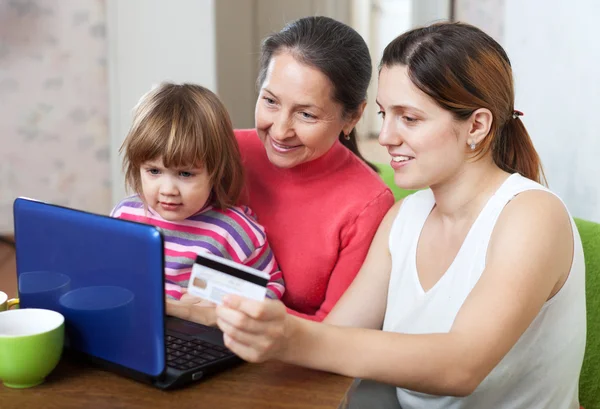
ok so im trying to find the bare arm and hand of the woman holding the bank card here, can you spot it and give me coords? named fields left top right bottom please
left=217, top=191, right=573, bottom=396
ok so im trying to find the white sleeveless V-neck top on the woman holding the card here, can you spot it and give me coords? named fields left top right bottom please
left=383, top=174, right=586, bottom=409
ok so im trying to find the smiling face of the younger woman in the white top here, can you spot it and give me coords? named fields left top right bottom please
left=377, top=65, right=469, bottom=189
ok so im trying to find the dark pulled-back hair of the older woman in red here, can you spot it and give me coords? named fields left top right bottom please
left=256, top=16, right=379, bottom=172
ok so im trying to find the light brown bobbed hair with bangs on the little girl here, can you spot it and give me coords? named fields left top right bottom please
left=119, top=83, right=244, bottom=208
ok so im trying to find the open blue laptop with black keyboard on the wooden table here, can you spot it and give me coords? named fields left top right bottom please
left=13, top=198, right=242, bottom=389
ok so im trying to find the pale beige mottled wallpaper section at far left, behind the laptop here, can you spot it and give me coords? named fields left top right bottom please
left=0, top=0, right=110, bottom=233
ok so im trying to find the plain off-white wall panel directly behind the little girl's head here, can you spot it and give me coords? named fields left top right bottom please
left=106, top=0, right=218, bottom=204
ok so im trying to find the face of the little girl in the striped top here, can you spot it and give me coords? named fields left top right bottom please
left=140, top=158, right=213, bottom=222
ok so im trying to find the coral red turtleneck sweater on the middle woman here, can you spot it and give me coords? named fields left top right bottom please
left=235, top=129, right=394, bottom=321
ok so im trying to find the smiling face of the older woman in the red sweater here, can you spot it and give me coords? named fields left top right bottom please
left=255, top=53, right=355, bottom=168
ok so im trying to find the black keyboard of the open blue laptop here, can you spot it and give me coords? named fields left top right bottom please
left=166, top=335, right=234, bottom=371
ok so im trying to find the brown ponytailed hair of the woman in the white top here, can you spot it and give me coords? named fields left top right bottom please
left=379, top=23, right=546, bottom=183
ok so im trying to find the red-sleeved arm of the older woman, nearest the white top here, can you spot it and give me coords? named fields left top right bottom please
left=288, top=189, right=394, bottom=321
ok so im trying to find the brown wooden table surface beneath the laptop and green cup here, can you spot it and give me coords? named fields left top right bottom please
left=0, top=244, right=352, bottom=409
